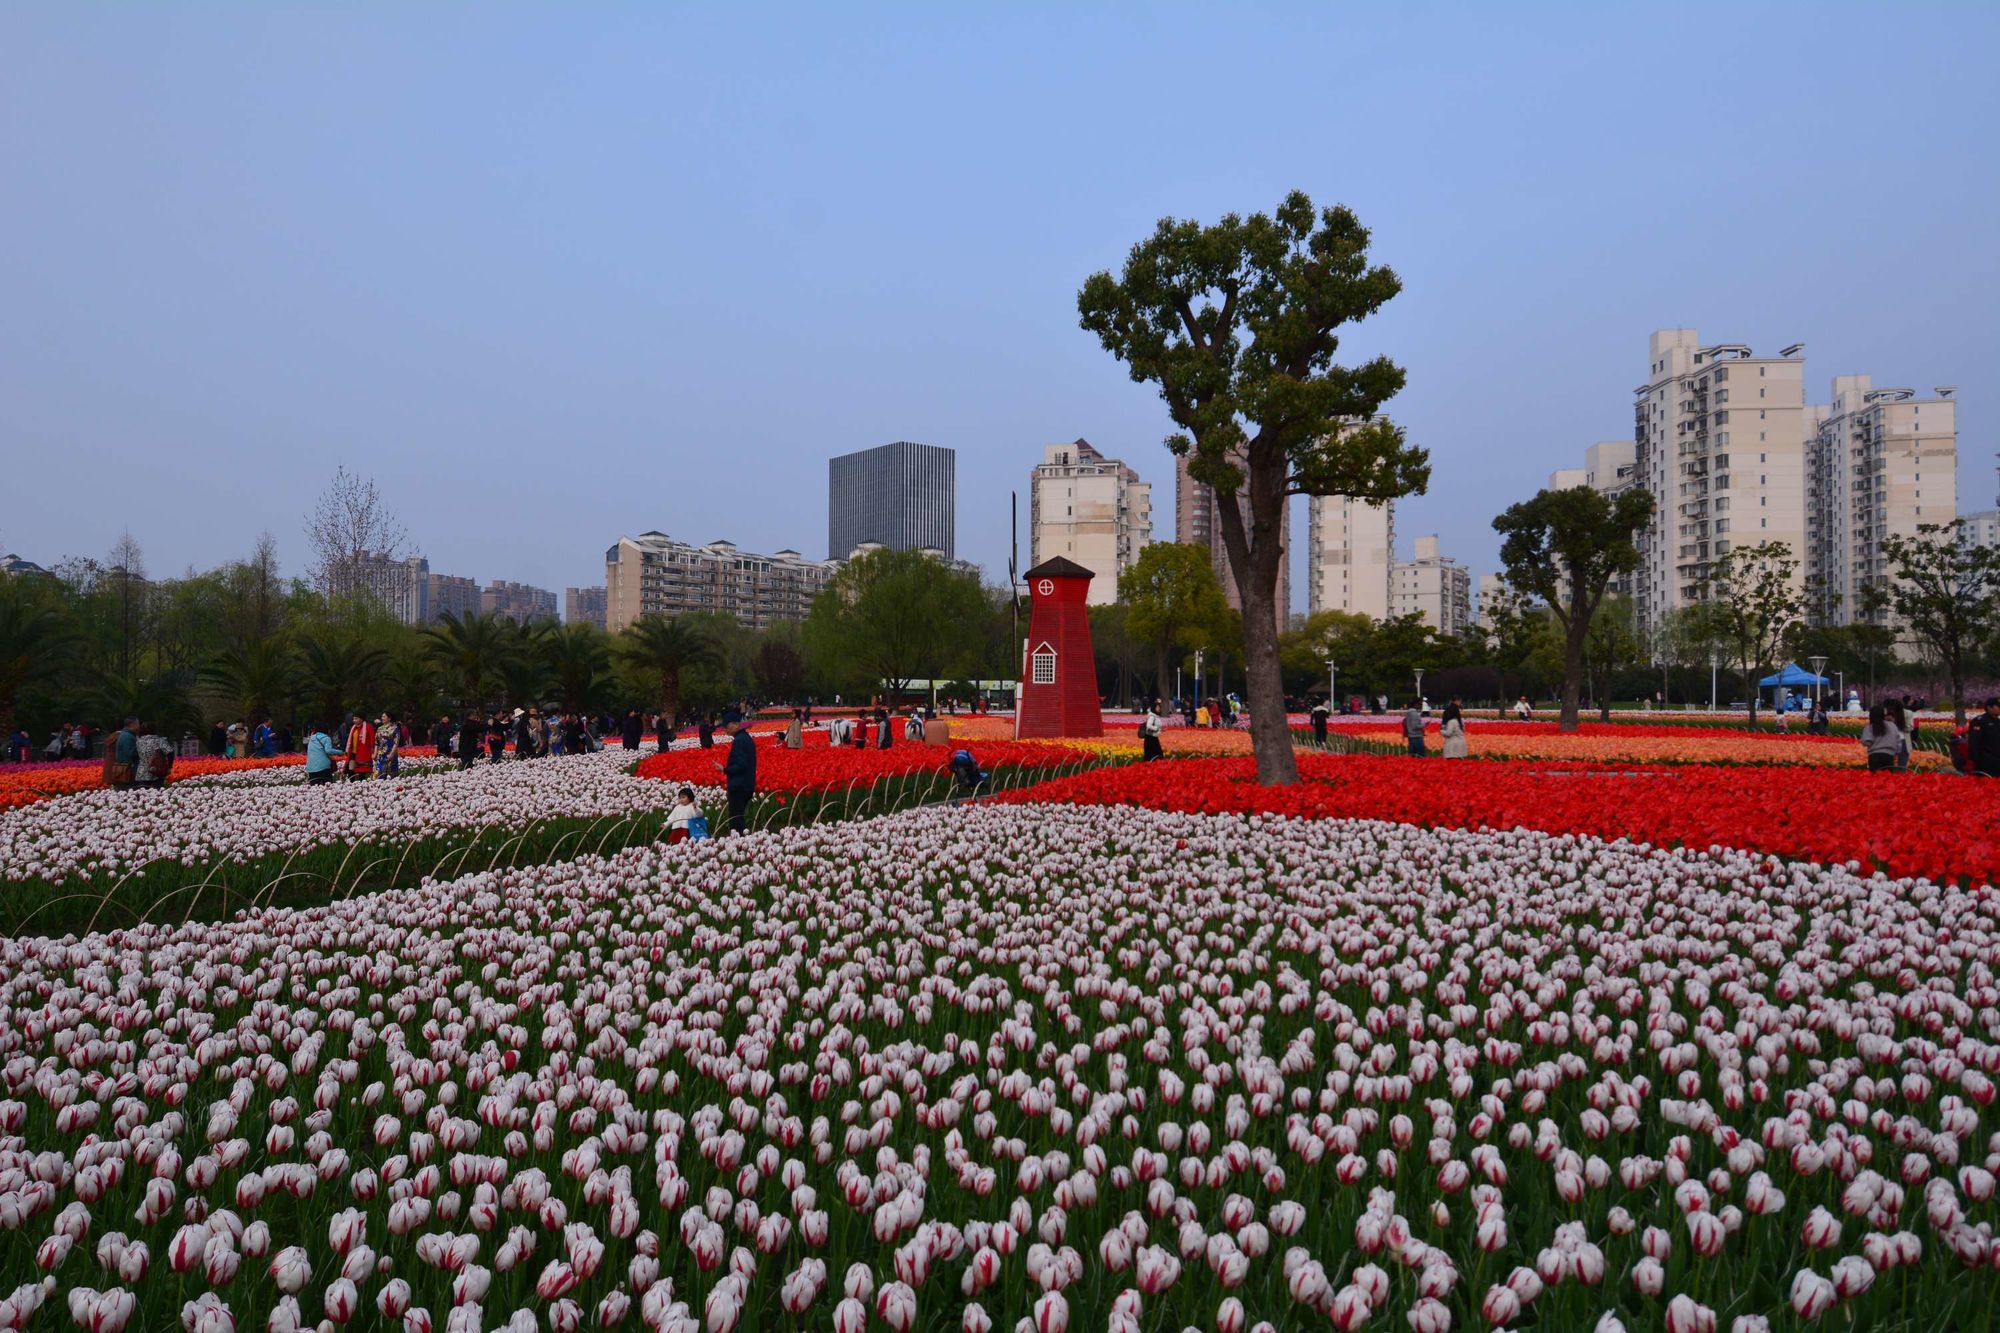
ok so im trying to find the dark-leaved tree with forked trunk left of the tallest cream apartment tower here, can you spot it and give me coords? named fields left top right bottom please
left=1494, top=486, right=1652, bottom=731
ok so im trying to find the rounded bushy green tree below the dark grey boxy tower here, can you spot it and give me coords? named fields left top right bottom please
left=802, top=550, right=988, bottom=695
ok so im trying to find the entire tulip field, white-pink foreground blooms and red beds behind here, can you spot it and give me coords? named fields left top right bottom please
left=0, top=725, right=2000, bottom=1333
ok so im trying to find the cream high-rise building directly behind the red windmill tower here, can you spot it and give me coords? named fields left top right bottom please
left=1028, top=440, right=1152, bottom=606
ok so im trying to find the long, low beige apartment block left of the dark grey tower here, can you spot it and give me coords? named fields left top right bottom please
left=604, top=532, right=840, bottom=634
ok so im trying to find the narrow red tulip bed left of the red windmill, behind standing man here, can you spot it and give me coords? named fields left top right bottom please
left=638, top=731, right=1096, bottom=793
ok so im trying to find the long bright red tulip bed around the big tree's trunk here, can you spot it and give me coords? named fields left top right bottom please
left=1000, top=755, right=2000, bottom=883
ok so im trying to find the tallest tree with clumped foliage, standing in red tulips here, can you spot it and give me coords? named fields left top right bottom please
left=1076, top=190, right=1430, bottom=785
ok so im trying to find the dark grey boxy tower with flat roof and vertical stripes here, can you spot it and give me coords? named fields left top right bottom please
left=826, top=440, right=958, bottom=560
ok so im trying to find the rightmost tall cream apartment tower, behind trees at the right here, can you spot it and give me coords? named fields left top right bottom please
left=1804, top=374, right=1958, bottom=624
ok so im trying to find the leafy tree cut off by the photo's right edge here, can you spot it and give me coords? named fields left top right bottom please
left=1864, top=518, right=2000, bottom=727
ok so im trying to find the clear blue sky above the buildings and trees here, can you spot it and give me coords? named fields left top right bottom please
left=0, top=2, right=2000, bottom=606
